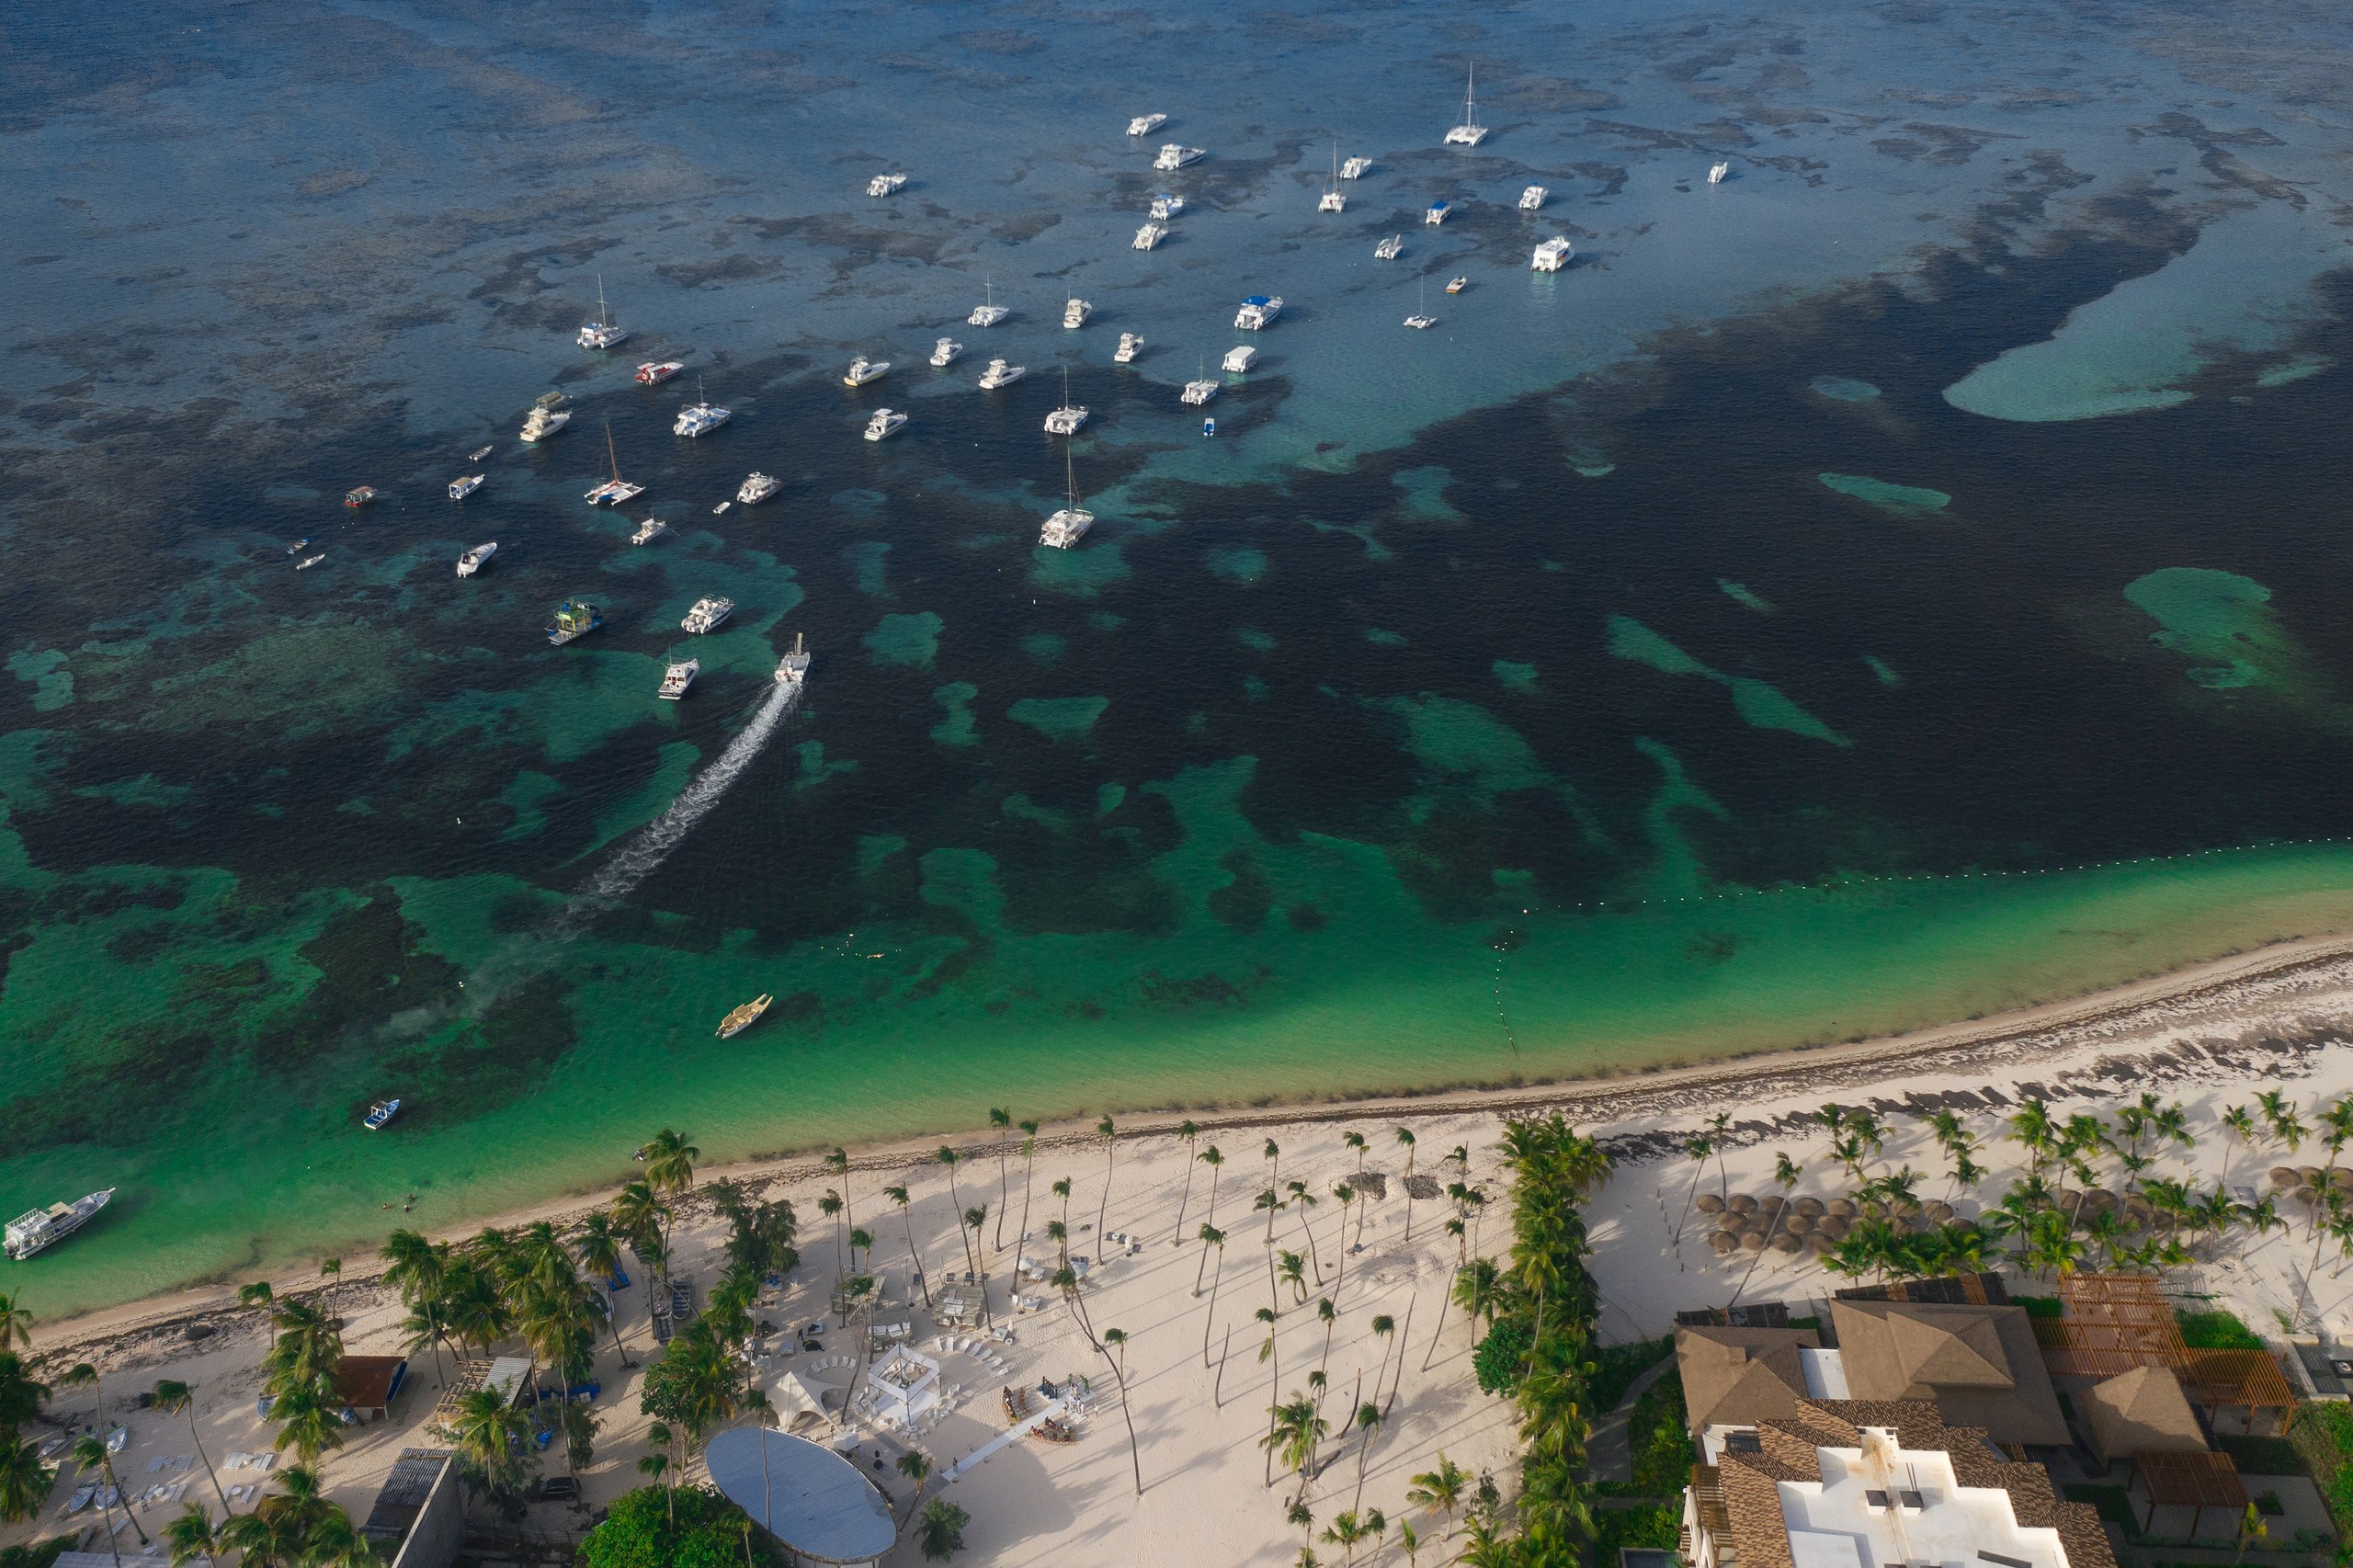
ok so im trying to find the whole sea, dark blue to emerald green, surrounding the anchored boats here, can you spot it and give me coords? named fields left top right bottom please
left=0, top=5, right=2353, bottom=1313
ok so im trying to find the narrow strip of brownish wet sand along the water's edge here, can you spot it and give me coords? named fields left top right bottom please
left=17, top=937, right=2353, bottom=1363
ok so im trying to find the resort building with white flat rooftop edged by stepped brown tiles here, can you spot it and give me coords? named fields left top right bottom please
left=1682, top=1399, right=2115, bottom=1568
